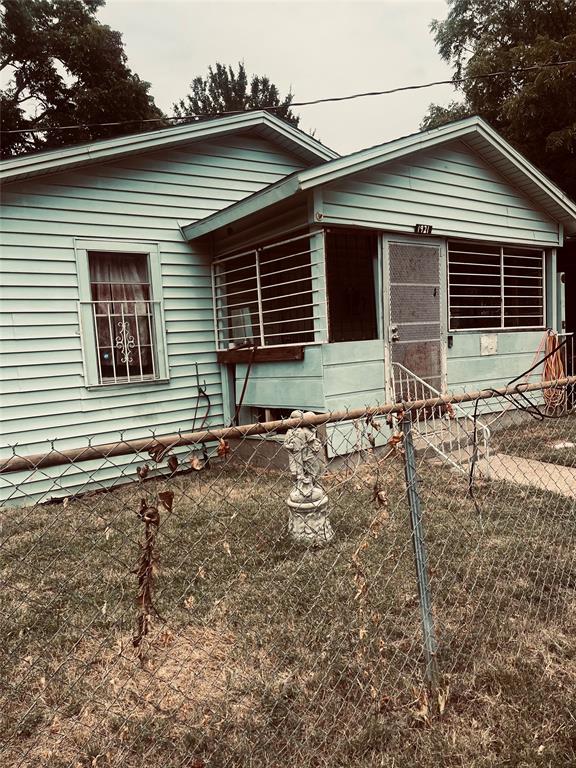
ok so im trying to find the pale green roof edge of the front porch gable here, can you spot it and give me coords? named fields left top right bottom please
left=182, top=117, right=576, bottom=240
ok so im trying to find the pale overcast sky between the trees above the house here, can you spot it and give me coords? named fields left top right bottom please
left=98, top=0, right=455, bottom=153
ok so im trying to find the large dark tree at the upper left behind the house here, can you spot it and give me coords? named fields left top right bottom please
left=0, top=0, right=162, bottom=157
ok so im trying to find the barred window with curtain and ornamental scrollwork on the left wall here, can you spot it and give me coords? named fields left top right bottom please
left=88, top=251, right=157, bottom=384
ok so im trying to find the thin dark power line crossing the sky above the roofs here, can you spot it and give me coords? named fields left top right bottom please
left=0, top=59, right=576, bottom=134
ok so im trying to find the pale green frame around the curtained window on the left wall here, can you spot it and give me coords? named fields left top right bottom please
left=74, top=238, right=170, bottom=389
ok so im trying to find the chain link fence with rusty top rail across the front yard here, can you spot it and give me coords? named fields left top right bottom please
left=0, top=379, right=576, bottom=768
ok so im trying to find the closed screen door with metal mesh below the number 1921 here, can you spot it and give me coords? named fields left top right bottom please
left=388, top=241, right=442, bottom=397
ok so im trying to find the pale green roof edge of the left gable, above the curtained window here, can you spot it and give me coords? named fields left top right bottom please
left=0, top=110, right=338, bottom=181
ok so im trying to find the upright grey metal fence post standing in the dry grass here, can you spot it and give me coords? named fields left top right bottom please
left=401, top=412, right=438, bottom=691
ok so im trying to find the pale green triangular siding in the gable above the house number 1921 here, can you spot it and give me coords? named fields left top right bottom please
left=323, top=142, right=559, bottom=245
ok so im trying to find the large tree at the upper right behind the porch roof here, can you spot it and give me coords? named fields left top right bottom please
left=422, top=0, right=576, bottom=197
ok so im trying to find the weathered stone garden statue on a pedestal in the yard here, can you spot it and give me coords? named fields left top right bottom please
left=284, top=411, right=334, bottom=547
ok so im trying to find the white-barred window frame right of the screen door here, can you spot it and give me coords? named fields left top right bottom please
left=446, top=238, right=548, bottom=334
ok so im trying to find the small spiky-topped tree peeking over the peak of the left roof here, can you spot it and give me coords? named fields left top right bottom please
left=174, top=62, right=300, bottom=126
